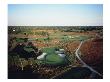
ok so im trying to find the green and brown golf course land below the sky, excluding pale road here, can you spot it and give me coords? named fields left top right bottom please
left=8, top=26, right=103, bottom=79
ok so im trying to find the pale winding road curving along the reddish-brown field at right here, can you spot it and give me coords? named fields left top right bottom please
left=75, top=41, right=102, bottom=77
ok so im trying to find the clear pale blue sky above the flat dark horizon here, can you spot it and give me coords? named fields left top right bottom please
left=8, top=4, right=103, bottom=26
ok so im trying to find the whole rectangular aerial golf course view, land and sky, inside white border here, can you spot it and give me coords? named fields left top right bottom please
left=7, top=4, right=103, bottom=79
